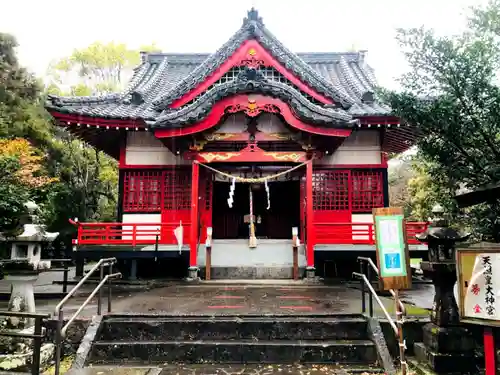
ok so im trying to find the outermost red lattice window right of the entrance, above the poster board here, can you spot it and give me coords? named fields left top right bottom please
left=351, top=171, right=384, bottom=212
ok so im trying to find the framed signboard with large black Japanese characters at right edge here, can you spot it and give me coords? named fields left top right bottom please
left=457, top=243, right=500, bottom=327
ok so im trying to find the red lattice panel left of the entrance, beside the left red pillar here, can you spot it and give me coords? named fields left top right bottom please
left=163, top=168, right=192, bottom=211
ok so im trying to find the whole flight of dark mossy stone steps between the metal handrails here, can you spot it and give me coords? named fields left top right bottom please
left=85, top=315, right=380, bottom=373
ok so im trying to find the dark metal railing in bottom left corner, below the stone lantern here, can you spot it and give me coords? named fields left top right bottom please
left=0, top=311, right=50, bottom=375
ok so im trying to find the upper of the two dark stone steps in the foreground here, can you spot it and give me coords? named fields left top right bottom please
left=96, top=316, right=367, bottom=342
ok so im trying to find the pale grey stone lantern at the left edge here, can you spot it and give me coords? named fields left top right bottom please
left=0, top=202, right=59, bottom=329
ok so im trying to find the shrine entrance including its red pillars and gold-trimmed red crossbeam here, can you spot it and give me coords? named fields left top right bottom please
left=189, top=143, right=314, bottom=279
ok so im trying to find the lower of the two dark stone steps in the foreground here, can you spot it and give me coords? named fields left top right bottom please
left=88, top=340, right=377, bottom=365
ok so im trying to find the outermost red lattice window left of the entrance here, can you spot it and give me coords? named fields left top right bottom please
left=123, top=171, right=162, bottom=212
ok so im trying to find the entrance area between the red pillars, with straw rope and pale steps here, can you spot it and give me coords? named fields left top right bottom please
left=193, top=162, right=309, bottom=279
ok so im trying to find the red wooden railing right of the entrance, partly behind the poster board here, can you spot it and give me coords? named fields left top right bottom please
left=314, top=222, right=428, bottom=245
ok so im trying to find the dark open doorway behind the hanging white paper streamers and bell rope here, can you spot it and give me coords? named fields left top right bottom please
left=212, top=180, right=301, bottom=240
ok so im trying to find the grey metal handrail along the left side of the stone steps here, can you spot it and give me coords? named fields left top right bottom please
left=54, top=258, right=122, bottom=375
